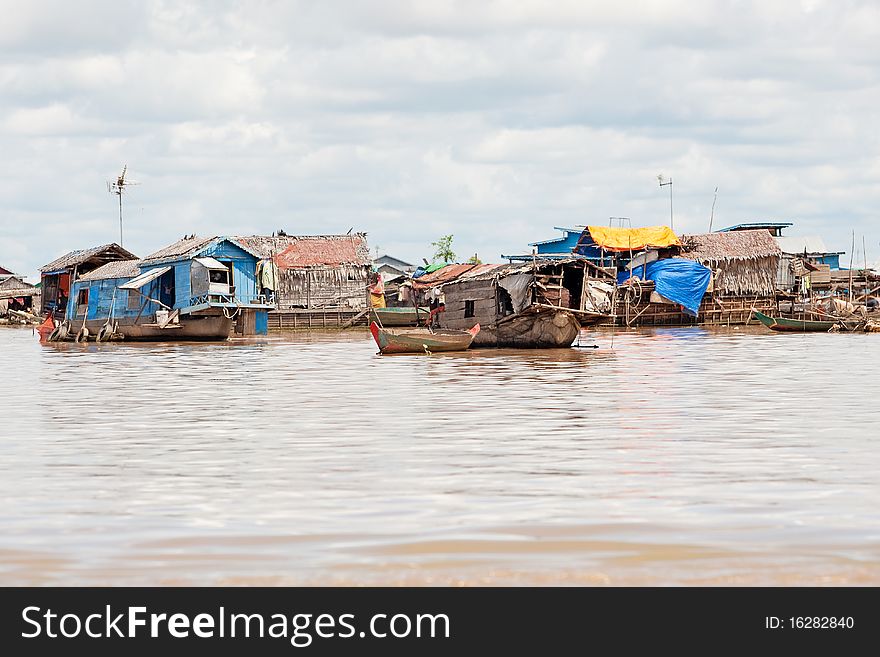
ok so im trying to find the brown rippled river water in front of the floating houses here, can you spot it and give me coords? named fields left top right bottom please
left=0, top=327, right=880, bottom=586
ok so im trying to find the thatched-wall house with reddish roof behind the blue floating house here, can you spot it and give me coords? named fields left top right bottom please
left=236, top=233, right=373, bottom=312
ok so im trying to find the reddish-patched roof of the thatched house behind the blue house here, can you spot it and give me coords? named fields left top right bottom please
left=236, top=233, right=373, bottom=269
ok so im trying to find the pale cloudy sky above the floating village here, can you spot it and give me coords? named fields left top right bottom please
left=0, top=0, right=880, bottom=276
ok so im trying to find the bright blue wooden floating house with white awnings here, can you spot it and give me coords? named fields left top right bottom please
left=49, top=236, right=274, bottom=340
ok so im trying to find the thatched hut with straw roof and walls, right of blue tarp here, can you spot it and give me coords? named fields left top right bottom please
left=681, top=230, right=782, bottom=297
